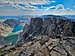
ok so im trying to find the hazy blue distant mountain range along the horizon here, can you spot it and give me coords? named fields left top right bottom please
left=0, top=15, right=75, bottom=20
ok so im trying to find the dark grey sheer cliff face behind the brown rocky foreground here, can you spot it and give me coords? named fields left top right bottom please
left=19, top=16, right=75, bottom=42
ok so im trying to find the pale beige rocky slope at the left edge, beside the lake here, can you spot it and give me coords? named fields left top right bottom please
left=0, top=23, right=12, bottom=37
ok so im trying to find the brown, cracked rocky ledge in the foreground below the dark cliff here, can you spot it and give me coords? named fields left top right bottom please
left=0, top=35, right=75, bottom=56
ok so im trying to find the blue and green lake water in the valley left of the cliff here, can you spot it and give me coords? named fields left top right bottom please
left=5, top=24, right=23, bottom=44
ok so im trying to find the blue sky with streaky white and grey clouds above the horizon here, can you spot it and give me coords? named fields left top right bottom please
left=0, top=0, right=75, bottom=16
